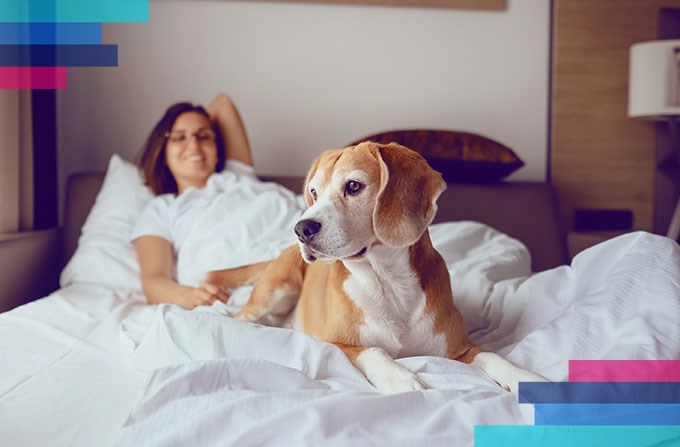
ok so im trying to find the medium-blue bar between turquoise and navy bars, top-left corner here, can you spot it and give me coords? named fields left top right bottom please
left=0, top=22, right=102, bottom=45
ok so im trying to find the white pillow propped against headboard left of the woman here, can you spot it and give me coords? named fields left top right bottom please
left=60, top=154, right=153, bottom=290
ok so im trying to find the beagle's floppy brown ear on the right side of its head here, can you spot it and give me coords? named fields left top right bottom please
left=373, top=143, right=446, bottom=247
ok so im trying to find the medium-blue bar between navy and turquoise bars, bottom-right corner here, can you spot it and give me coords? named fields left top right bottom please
left=534, top=404, right=680, bottom=425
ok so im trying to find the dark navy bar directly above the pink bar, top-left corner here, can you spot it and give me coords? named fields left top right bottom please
left=0, top=45, right=118, bottom=67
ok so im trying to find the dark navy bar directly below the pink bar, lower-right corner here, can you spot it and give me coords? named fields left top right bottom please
left=519, top=382, right=680, bottom=404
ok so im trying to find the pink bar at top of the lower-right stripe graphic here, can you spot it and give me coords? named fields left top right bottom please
left=569, top=360, right=680, bottom=382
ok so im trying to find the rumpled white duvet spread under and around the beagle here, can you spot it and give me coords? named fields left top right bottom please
left=115, top=231, right=680, bottom=446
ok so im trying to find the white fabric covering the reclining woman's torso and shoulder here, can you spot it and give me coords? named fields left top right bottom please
left=130, top=162, right=305, bottom=286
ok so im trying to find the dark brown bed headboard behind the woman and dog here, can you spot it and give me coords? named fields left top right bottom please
left=63, top=172, right=568, bottom=272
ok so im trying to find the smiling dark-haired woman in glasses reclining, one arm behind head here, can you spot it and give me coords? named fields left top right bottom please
left=132, top=94, right=254, bottom=309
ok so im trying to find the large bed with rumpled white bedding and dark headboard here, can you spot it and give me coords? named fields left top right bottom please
left=0, top=145, right=680, bottom=446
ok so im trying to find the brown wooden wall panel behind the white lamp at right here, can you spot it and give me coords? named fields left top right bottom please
left=550, top=0, right=680, bottom=231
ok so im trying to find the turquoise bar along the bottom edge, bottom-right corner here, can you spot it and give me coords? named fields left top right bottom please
left=474, top=425, right=680, bottom=447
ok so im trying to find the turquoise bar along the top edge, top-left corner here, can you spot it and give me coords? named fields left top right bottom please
left=0, top=0, right=149, bottom=23
